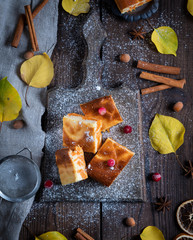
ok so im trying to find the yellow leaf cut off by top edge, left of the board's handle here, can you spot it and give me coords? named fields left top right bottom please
left=62, top=0, right=90, bottom=16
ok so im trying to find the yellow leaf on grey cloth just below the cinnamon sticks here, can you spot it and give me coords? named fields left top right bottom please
left=20, top=53, right=54, bottom=88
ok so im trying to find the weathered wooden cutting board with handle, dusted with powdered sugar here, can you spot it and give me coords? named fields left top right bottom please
left=38, top=15, right=145, bottom=201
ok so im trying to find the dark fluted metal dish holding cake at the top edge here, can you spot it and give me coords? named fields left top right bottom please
left=105, top=0, right=159, bottom=22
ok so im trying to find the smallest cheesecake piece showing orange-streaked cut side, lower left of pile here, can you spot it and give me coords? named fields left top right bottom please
left=55, top=146, right=88, bottom=185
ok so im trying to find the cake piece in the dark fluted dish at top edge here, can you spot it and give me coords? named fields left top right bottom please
left=115, top=0, right=151, bottom=13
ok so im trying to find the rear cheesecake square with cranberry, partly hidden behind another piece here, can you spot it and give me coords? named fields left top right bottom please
left=80, top=96, right=123, bottom=132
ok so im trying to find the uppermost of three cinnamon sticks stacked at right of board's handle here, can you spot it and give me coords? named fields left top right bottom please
left=137, top=60, right=181, bottom=75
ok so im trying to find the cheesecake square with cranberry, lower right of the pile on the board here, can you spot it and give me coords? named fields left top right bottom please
left=87, top=138, right=135, bottom=187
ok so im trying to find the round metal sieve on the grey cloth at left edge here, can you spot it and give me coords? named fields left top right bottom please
left=0, top=148, right=41, bottom=202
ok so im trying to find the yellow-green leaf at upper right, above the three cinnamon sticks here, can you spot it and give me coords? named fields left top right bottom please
left=151, top=27, right=178, bottom=56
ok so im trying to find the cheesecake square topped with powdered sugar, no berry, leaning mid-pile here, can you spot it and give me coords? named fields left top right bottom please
left=63, top=113, right=102, bottom=153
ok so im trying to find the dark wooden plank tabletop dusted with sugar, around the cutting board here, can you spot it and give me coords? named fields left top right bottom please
left=20, top=0, right=193, bottom=240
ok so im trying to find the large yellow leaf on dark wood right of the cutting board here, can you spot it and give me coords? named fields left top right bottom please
left=149, top=114, right=185, bottom=154
